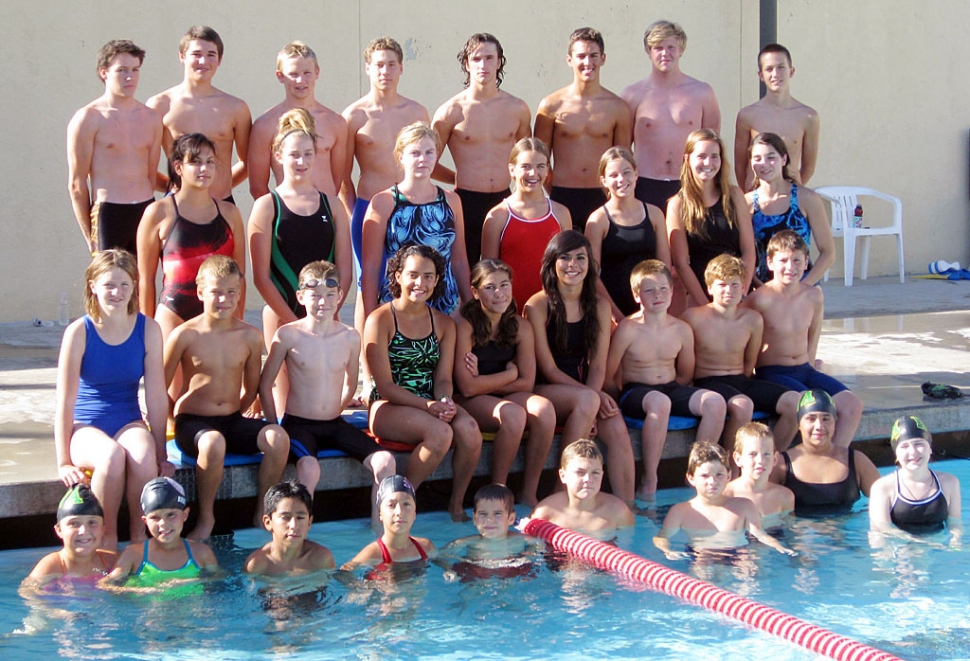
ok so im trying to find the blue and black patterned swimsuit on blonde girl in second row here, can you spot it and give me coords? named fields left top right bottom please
left=378, top=185, right=459, bottom=314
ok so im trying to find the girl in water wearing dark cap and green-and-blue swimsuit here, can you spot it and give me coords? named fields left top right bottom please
left=105, top=477, right=219, bottom=587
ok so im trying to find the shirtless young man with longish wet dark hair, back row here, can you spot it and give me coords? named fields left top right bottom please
left=431, top=32, right=532, bottom=264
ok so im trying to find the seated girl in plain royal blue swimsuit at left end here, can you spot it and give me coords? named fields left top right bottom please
left=54, top=250, right=167, bottom=550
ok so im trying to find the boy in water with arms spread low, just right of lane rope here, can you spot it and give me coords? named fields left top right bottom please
left=653, top=441, right=795, bottom=560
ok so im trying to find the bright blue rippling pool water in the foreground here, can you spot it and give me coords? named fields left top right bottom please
left=0, top=460, right=970, bottom=661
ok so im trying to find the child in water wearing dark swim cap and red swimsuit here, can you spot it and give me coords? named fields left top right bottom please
left=341, top=475, right=434, bottom=570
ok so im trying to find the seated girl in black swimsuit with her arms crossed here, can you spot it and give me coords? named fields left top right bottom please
left=455, top=260, right=556, bottom=505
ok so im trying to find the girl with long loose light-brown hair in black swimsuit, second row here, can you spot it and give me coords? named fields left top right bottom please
left=667, top=129, right=755, bottom=313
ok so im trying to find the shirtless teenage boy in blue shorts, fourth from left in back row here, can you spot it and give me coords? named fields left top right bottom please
left=340, top=37, right=431, bottom=276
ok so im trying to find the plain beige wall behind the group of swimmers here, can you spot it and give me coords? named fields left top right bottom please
left=0, top=0, right=970, bottom=321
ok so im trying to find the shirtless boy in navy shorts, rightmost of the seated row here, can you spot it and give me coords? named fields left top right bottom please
left=744, top=230, right=863, bottom=449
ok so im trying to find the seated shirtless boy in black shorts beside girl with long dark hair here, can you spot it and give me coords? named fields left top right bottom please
left=606, top=259, right=726, bottom=501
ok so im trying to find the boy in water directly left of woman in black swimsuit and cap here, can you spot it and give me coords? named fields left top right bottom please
left=724, top=422, right=795, bottom=529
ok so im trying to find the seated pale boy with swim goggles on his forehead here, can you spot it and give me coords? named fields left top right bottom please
left=259, top=261, right=396, bottom=528
